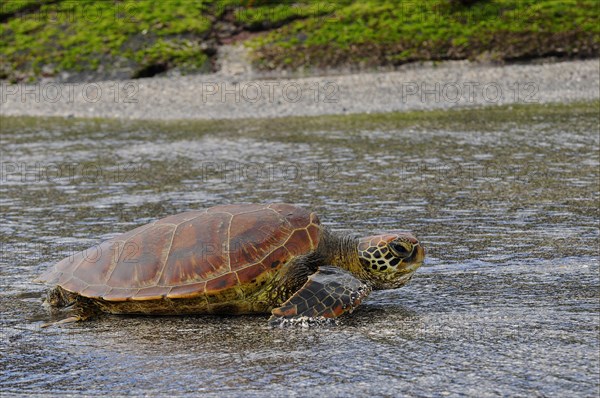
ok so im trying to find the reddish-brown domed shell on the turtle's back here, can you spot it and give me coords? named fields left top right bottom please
left=39, top=204, right=320, bottom=301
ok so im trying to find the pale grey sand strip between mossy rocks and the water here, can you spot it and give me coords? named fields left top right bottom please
left=0, top=59, right=600, bottom=120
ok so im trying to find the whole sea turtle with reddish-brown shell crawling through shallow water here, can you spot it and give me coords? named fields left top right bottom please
left=38, top=203, right=425, bottom=324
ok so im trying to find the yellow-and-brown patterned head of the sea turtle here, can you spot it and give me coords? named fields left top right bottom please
left=358, top=233, right=425, bottom=290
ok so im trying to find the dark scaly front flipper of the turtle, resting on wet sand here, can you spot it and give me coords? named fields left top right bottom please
left=269, top=266, right=371, bottom=326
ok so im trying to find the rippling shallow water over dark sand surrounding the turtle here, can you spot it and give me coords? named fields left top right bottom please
left=0, top=103, right=600, bottom=396
